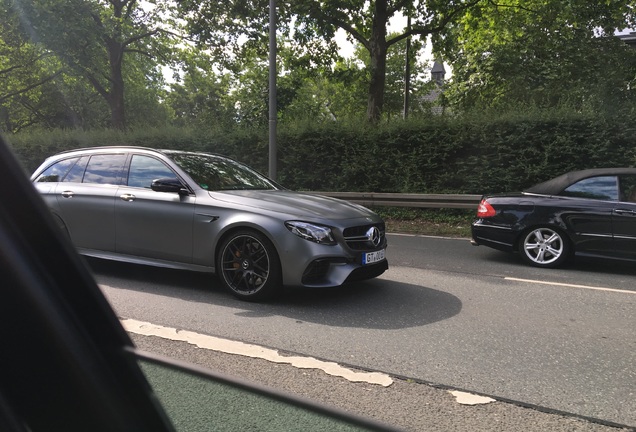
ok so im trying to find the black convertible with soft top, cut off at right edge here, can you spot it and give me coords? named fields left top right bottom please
left=472, top=168, right=636, bottom=267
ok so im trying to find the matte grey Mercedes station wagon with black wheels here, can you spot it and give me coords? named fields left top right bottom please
left=31, top=147, right=388, bottom=300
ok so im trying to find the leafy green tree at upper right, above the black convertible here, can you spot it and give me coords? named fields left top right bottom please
left=436, top=0, right=636, bottom=111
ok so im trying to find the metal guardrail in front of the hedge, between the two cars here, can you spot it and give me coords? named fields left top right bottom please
left=312, top=192, right=481, bottom=209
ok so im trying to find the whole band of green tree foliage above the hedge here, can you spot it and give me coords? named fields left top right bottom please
left=0, top=0, right=636, bottom=132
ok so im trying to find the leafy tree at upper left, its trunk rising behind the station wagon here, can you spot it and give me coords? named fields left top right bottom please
left=9, top=0, right=179, bottom=129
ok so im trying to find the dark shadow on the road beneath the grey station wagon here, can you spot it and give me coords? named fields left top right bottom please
left=87, top=259, right=462, bottom=329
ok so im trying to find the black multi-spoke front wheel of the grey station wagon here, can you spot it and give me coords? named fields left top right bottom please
left=217, top=231, right=281, bottom=301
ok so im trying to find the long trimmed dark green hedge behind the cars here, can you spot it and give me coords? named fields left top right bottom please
left=9, top=114, right=636, bottom=194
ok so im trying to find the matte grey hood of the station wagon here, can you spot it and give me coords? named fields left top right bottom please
left=208, top=190, right=379, bottom=221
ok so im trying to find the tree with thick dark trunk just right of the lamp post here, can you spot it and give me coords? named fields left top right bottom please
left=180, top=0, right=485, bottom=122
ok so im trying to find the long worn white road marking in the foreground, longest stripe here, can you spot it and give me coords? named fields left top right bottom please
left=121, top=319, right=393, bottom=387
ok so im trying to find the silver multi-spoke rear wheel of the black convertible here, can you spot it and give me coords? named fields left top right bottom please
left=519, top=227, right=570, bottom=267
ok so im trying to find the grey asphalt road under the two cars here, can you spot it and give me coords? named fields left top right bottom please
left=90, top=235, right=636, bottom=430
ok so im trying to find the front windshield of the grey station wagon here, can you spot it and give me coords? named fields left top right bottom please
left=169, top=153, right=277, bottom=191
